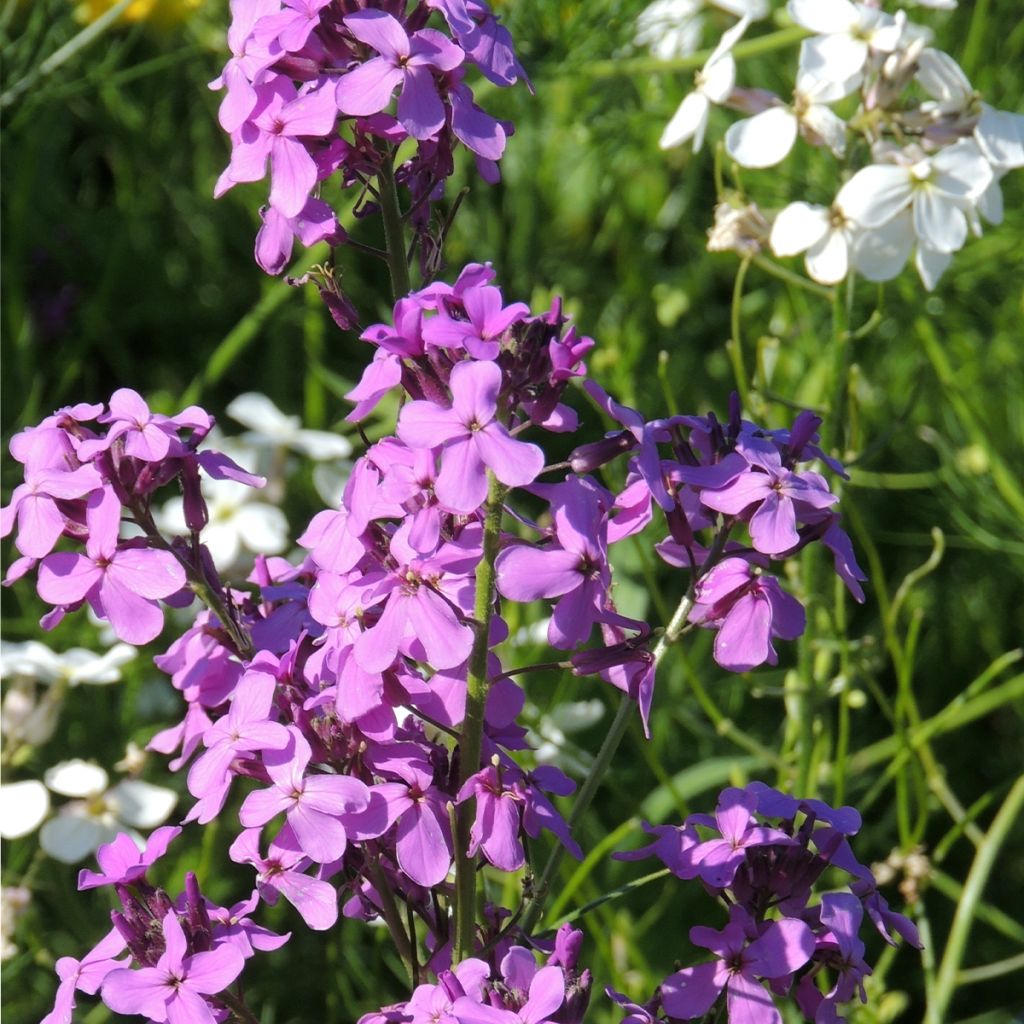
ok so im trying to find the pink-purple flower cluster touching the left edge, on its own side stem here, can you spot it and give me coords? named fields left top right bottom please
left=0, top=388, right=263, bottom=644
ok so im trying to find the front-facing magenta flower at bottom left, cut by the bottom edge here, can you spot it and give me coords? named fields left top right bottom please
left=101, top=910, right=245, bottom=1024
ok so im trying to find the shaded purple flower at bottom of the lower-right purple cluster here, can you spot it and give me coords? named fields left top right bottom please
left=662, top=906, right=814, bottom=1024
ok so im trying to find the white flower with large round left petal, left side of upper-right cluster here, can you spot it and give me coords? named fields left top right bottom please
left=725, top=57, right=856, bottom=168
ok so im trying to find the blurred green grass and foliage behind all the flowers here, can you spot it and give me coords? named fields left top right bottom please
left=0, top=0, right=1024, bottom=1024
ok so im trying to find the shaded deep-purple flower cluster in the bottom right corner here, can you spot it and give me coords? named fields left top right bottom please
left=609, top=782, right=921, bottom=1024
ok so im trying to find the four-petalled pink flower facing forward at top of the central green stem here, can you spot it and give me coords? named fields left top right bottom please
left=398, top=361, right=544, bottom=515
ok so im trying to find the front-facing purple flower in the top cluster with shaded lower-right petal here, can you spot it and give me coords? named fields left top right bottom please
left=336, top=10, right=465, bottom=139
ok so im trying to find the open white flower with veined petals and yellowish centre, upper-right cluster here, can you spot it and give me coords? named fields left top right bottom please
left=836, top=139, right=992, bottom=253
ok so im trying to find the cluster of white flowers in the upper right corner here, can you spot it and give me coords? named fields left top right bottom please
left=660, top=0, right=1024, bottom=289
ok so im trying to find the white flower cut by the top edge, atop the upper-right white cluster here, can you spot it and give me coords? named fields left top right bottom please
left=786, top=0, right=903, bottom=81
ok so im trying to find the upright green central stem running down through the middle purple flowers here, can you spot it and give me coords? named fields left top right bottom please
left=453, top=470, right=506, bottom=964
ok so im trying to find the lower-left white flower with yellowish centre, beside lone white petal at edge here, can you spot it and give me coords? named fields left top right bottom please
left=39, top=759, right=178, bottom=864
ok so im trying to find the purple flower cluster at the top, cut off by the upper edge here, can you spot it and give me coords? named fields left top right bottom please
left=207, top=0, right=526, bottom=273
